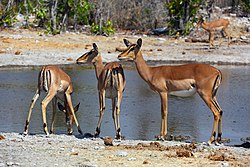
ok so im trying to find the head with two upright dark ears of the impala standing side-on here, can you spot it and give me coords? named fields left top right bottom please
left=118, top=38, right=142, bottom=61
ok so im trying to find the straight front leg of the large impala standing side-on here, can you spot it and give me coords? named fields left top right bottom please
left=158, top=92, right=168, bottom=140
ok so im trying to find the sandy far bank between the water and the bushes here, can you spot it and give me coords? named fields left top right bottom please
left=0, top=29, right=250, bottom=66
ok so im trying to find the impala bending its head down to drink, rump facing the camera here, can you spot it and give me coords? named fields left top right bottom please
left=24, top=65, right=82, bottom=135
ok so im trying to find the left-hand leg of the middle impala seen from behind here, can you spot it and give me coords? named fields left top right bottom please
left=94, top=90, right=105, bottom=137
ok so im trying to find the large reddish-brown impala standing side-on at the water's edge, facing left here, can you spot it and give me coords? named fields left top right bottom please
left=118, top=39, right=222, bottom=144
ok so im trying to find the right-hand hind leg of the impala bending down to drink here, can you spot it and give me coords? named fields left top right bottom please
left=42, top=92, right=56, bottom=136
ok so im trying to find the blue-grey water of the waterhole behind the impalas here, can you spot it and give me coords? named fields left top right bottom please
left=0, top=66, right=250, bottom=144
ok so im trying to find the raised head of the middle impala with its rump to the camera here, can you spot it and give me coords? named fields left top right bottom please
left=76, top=43, right=100, bottom=64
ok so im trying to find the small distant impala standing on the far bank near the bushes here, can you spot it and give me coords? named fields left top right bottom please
left=197, top=17, right=230, bottom=47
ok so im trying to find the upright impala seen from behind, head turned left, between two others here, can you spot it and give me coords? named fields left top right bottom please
left=76, top=43, right=126, bottom=139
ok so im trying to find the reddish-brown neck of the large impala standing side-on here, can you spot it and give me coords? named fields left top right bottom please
left=134, top=51, right=151, bottom=82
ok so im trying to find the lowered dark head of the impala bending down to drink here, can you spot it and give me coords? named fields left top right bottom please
left=57, top=102, right=80, bottom=135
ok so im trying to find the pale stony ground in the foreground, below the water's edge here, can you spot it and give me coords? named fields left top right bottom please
left=0, top=133, right=250, bottom=167
